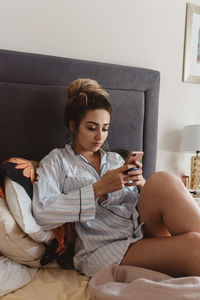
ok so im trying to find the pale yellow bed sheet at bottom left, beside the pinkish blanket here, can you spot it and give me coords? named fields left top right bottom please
left=1, top=268, right=89, bottom=300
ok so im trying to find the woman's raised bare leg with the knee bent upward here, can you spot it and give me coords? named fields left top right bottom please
left=138, top=172, right=200, bottom=236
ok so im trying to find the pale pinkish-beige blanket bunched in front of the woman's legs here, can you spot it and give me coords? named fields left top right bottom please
left=89, top=266, right=200, bottom=300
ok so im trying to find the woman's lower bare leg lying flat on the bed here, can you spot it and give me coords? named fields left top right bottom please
left=121, top=232, right=200, bottom=276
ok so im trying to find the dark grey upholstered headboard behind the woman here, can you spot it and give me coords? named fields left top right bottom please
left=0, top=50, right=160, bottom=178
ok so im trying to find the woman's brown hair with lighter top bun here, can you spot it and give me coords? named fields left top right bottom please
left=64, top=78, right=112, bottom=129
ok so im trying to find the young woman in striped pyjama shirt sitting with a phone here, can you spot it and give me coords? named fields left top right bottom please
left=33, top=79, right=200, bottom=276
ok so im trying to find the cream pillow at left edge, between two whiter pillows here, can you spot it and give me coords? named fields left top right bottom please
left=0, top=197, right=45, bottom=267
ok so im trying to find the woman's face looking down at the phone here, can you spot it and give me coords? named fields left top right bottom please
left=70, top=109, right=110, bottom=154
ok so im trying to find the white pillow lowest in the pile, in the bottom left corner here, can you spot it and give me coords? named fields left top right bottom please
left=0, top=256, right=37, bottom=297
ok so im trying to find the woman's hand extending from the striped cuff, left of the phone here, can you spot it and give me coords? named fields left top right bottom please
left=93, top=164, right=135, bottom=198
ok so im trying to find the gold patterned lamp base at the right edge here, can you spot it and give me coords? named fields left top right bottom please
left=190, top=152, right=200, bottom=190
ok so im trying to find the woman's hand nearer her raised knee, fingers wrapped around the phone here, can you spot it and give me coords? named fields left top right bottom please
left=125, top=160, right=145, bottom=190
